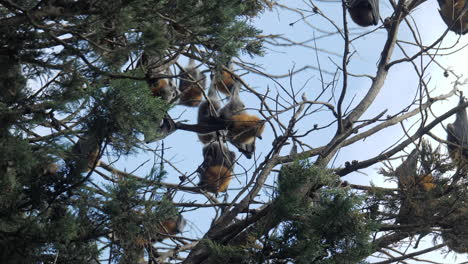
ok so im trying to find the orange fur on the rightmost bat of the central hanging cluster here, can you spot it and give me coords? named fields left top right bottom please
left=228, top=114, right=265, bottom=144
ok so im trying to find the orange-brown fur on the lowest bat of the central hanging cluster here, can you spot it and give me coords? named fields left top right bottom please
left=202, top=165, right=232, bottom=193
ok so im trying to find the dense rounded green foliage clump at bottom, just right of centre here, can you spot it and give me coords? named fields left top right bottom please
left=265, top=161, right=376, bottom=263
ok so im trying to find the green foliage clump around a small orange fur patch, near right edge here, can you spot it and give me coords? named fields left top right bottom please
left=374, top=141, right=461, bottom=227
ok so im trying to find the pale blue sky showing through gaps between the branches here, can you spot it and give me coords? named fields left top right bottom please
left=88, top=0, right=468, bottom=263
